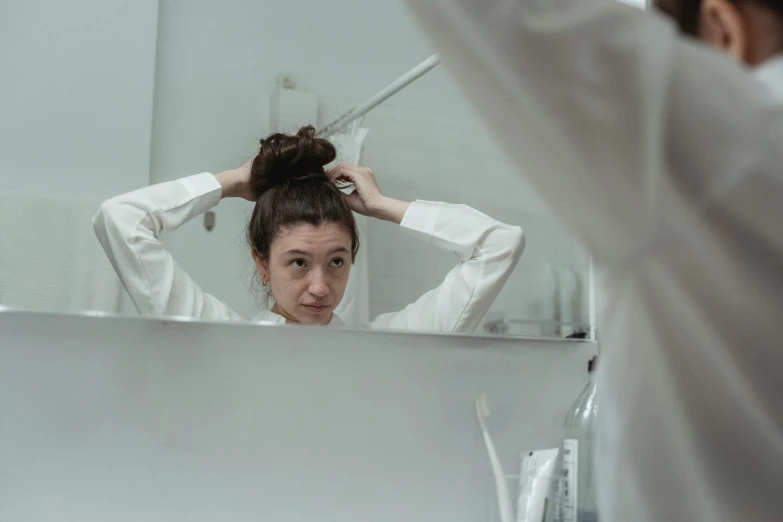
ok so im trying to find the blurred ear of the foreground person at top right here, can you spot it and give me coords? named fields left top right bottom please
left=699, top=0, right=748, bottom=63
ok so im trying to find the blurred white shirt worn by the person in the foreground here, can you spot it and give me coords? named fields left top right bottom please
left=408, top=0, right=783, bottom=522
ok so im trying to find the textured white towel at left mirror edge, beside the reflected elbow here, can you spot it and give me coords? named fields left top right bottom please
left=0, top=194, right=123, bottom=312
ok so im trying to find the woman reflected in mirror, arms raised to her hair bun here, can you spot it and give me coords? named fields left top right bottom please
left=93, top=127, right=524, bottom=332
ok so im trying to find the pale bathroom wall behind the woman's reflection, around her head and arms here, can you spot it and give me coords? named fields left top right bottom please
left=147, top=0, right=585, bottom=324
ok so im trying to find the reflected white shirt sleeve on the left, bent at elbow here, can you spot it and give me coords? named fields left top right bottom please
left=93, top=173, right=241, bottom=320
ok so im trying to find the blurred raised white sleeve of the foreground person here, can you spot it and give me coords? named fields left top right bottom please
left=408, top=0, right=772, bottom=264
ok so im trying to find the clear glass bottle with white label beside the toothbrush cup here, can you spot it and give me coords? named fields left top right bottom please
left=559, top=357, right=598, bottom=522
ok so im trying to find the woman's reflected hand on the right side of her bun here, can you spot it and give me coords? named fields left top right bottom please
left=326, top=163, right=409, bottom=224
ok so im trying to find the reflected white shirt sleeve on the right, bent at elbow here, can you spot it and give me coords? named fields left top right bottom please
left=371, top=201, right=524, bottom=332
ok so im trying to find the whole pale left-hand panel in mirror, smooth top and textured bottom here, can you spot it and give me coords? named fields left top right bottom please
left=0, top=0, right=158, bottom=311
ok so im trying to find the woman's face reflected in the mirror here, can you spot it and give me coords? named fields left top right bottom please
left=256, top=223, right=351, bottom=324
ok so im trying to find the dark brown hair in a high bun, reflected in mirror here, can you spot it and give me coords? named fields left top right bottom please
left=247, top=126, right=359, bottom=261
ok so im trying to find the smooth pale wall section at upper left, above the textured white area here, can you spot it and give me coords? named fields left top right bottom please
left=0, top=0, right=158, bottom=203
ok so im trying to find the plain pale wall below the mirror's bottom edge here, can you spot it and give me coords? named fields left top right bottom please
left=0, top=312, right=594, bottom=522
